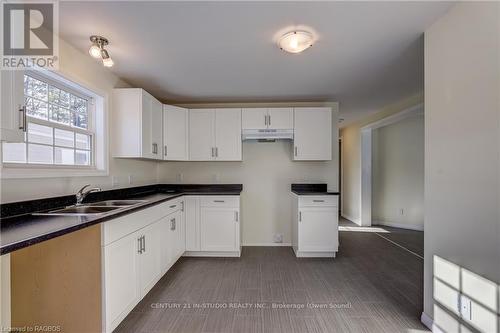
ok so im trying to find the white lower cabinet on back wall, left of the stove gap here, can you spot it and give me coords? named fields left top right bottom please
left=184, top=196, right=241, bottom=257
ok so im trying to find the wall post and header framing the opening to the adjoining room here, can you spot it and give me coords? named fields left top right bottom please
left=340, top=94, right=423, bottom=224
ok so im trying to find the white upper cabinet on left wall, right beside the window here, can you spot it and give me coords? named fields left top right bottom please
left=112, top=88, right=163, bottom=159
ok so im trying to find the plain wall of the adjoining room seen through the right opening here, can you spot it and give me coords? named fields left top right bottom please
left=372, top=115, right=424, bottom=230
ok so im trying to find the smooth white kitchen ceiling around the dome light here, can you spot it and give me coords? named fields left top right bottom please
left=60, top=1, right=452, bottom=124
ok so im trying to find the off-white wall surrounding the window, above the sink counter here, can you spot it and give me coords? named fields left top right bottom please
left=0, top=36, right=157, bottom=203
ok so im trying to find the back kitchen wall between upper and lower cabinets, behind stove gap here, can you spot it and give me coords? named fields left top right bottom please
left=159, top=108, right=338, bottom=245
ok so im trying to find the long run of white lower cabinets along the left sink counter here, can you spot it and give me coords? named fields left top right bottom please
left=102, top=200, right=185, bottom=332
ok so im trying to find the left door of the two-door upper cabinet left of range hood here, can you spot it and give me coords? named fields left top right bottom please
left=189, top=109, right=215, bottom=161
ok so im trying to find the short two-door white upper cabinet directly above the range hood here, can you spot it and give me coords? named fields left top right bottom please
left=242, top=108, right=293, bottom=129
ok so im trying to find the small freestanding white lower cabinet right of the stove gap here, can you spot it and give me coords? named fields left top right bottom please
left=292, top=195, right=339, bottom=257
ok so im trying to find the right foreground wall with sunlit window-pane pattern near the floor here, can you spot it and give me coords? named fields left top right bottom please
left=424, top=2, right=500, bottom=332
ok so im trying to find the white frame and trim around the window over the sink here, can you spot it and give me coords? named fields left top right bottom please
left=0, top=69, right=109, bottom=179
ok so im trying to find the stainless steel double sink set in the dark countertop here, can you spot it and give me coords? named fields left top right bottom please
left=33, top=200, right=147, bottom=216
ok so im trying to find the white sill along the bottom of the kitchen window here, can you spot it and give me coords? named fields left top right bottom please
left=0, top=164, right=109, bottom=179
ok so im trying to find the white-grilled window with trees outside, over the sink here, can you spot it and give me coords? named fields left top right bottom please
left=2, top=73, right=95, bottom=168
